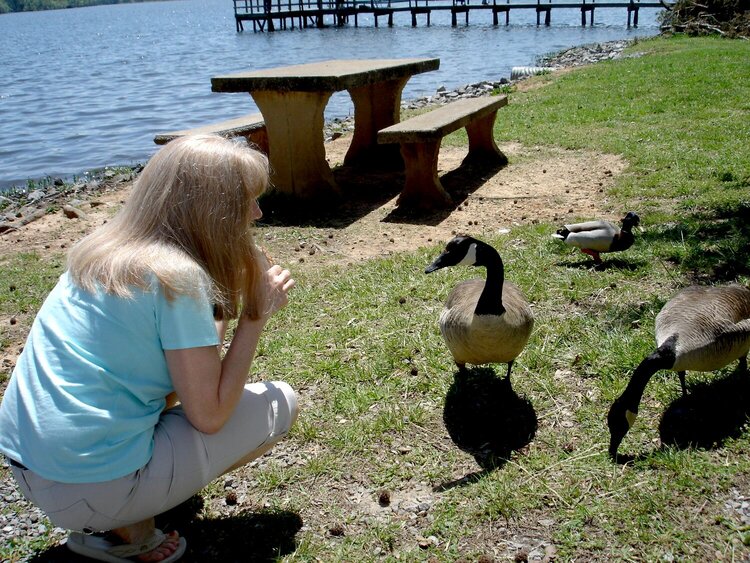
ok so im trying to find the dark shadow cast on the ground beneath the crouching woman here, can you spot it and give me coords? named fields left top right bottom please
left=30, top=495, right=303, bottom=563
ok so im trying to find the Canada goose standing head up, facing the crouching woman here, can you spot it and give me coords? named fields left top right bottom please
left=425, top=236, right=534, bottom=388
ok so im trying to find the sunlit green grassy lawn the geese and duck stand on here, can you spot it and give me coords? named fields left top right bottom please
left=0, top=38, right=750, bottom=561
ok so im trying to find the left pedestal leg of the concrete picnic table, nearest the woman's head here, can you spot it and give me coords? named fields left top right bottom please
left=251, top=90, right=337, bottom=199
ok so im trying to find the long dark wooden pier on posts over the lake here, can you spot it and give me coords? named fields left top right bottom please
left=234, top=0, right=668, bottom=31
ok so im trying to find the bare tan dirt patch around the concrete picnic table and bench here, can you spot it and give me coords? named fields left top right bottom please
left=0, top=138, right=626, bottom=268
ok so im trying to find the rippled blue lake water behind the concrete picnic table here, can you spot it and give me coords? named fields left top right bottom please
left=0, top=0, right=659, bottom=188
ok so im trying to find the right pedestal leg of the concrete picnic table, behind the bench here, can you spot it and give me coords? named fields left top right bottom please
left=344, top=77, right=409, bottom=169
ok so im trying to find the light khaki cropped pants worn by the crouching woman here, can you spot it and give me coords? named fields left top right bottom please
left=11, top=381, right=297, bottom=533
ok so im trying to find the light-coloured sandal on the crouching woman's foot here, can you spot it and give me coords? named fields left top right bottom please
left=67, top=529, right=187, bottom=563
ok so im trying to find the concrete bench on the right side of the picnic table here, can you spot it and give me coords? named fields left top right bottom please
left=378, top=96, right=508, bottom=209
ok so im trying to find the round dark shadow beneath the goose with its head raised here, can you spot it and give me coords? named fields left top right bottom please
left=443, top=367, right=537, bottom=476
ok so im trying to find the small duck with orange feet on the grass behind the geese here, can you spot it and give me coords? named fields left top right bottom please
left=552, top=211, right=641, bottom=264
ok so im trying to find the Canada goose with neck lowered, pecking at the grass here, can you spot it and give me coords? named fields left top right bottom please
left=607, top=284, right=750, bottom=459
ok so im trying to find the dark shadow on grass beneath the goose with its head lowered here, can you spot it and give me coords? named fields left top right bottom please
left=616, top=369, right=750, bottom=465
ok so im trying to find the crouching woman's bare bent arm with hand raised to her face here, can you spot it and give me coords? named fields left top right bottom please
left=165, top=265, right=294, bottom=434
